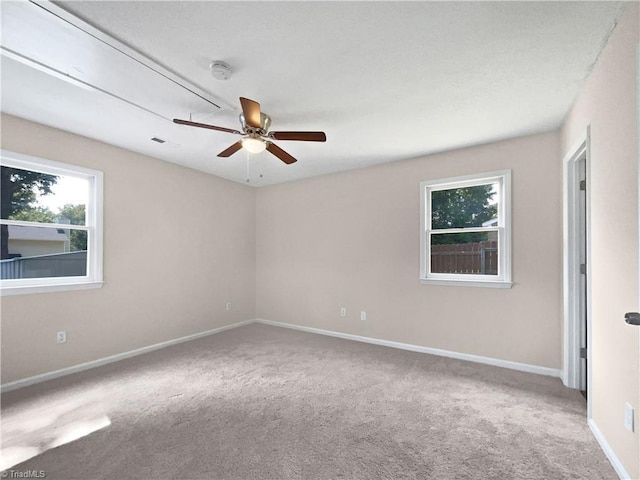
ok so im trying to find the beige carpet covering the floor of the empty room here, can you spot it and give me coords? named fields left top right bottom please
left=2, top=325, right=617, bottom=480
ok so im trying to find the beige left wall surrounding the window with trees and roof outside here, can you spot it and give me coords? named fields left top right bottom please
left=1, top=116, right=255, bottom=383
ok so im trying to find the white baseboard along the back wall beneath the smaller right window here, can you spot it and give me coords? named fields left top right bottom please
left=255, top=318, right=560, bottom=378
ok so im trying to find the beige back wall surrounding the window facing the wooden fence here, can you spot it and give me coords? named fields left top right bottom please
left=256, top=132, right=562, bottom=369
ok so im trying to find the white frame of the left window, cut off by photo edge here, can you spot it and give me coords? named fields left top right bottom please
left=0, top=150, right=103, bottom=296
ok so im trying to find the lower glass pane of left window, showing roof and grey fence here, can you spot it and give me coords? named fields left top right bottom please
left=0, top=225, right=87, bottom=280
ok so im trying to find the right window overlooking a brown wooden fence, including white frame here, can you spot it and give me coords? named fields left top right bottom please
left=420, top=170, right=512, bottom=288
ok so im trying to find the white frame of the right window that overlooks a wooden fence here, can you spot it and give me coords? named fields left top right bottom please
left=420, top=170, right=513, bottom=288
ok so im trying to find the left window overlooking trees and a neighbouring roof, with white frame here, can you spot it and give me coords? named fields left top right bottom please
left=0, top=150, right=102, bottom=295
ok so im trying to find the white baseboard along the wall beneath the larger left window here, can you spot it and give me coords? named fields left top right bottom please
left=0, top=319, right=255, bottom=393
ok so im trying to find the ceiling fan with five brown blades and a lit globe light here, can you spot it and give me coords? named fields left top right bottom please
left=173, top=97, right=327, bottom=164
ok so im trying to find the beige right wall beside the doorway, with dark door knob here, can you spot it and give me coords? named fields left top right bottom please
left=562, top=3, right=640, bottom=478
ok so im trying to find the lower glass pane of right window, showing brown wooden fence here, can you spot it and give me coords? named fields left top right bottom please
left=430, top=231, right=498, bottom=275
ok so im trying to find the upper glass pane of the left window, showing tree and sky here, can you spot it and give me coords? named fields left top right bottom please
left=1, top=166, right=89, bottom=225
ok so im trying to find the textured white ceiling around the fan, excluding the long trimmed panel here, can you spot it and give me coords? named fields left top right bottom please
left=2, top=1, right=624, bottom=186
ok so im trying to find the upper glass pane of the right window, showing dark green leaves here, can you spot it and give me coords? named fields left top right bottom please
left=431, top=183, right=499, bottom=229
